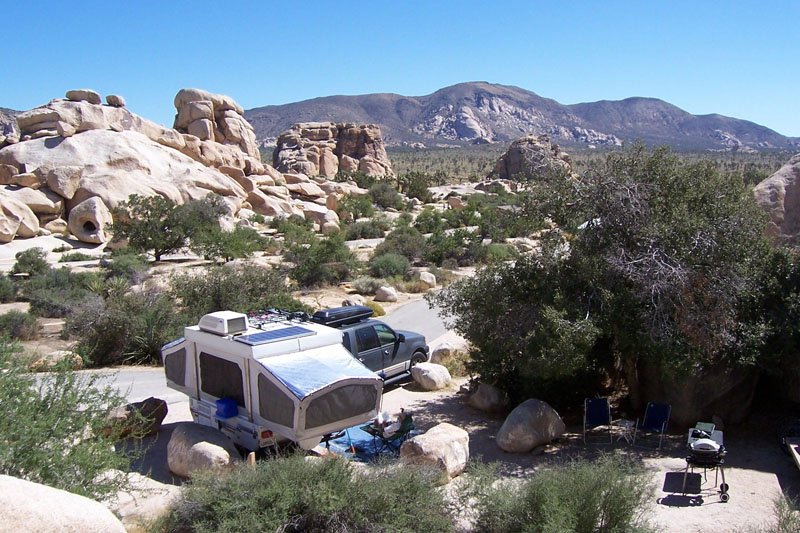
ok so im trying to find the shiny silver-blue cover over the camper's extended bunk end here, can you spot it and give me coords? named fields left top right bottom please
left=258, top=344, right=380, bottom=400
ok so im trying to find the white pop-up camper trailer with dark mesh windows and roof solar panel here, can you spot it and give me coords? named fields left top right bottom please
left=161, top=311, right=383, bottom=450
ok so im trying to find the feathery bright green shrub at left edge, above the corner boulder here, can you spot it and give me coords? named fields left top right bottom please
left=0, top=339, right=136, bottom=499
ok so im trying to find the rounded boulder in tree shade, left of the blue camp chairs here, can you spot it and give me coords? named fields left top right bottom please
left=496, top=399, right=566, bottom=453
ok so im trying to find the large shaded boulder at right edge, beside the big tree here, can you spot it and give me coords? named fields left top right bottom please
left=753, top=154, right=800, bottom=244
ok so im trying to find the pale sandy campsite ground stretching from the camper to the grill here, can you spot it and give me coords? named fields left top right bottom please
left=131, top=366, right=800, bottom=533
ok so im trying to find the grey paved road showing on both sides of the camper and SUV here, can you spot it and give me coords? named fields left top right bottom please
left=101, top=300, right=447, bottom=404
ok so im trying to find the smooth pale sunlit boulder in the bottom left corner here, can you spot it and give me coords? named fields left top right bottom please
left=0, top=475, right=125, bottom=533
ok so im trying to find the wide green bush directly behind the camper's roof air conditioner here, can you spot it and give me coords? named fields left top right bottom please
left=170, top=265, right=310, bottom=324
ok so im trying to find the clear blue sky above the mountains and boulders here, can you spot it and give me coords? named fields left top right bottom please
left=6, top=0, right=800, bottom=136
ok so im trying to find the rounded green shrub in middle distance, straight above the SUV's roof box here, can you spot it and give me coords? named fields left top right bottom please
left=283, top=233, right=358, bottom=287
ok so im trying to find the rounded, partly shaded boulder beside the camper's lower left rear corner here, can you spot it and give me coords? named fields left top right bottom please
left=167, top=422, right=241, bottom=478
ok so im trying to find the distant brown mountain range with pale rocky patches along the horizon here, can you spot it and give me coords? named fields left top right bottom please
left=244, top=82, right=800, bottom=151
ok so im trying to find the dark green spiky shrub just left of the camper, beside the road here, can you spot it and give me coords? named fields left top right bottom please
left=64, top=291, right=188, bottom=366
